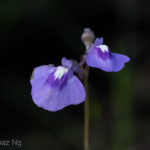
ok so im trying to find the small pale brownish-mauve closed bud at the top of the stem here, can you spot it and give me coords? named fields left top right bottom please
left=81, top=28, right=95, bottom=49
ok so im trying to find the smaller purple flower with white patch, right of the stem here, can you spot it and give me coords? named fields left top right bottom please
left=86, top=38, right=130, bottom=72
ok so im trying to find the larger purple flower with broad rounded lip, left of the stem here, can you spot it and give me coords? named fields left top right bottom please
left=30, top=58, right=85, bottom=111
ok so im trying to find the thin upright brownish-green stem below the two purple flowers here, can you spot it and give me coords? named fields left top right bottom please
left=84, top=65, right=89, bottom=150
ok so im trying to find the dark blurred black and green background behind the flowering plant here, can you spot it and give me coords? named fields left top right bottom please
left=0, top=0, right=150, bottom=150
